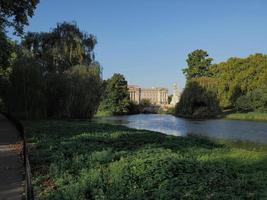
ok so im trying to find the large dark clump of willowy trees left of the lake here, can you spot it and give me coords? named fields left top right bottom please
left=0, top=22, right=102, bottom=119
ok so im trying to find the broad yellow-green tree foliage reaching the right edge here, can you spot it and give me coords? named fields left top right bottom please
left=210, top=54, right=267, bottom=110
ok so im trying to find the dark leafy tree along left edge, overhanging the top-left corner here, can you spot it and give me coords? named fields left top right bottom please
left=0, top=0, right=39, bottom=111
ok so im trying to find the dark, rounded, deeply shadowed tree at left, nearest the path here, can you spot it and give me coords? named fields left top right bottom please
left=4, top=52, right=46, bottom=119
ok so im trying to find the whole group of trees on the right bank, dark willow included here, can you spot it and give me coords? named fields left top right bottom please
left=175, top=50, right=267, bottom=118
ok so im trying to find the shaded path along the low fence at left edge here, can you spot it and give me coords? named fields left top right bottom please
left=0, top=114, right=23, bottom=200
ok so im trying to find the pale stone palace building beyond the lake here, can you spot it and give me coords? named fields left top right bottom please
left=128, top=85, right=168, bottom=105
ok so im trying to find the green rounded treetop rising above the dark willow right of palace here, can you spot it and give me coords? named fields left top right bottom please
left=183, top=49, right=213, bottom=80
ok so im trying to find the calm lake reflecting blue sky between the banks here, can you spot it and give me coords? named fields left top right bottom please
left=95, top=114, right=267, bottom=144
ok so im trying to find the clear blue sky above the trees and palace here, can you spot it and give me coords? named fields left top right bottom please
left=12, top=0, right=267, bottom=92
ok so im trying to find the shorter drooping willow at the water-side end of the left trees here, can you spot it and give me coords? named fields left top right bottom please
left=63, top=65, right=102, bottom=119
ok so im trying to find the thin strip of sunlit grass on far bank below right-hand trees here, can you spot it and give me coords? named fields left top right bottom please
left=225, top=112, right=267, bottom=121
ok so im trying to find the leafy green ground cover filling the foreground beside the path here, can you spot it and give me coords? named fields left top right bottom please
left=25, top=121, right=267, bottom=200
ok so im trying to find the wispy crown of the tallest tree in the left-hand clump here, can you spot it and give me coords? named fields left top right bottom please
left=22, top=22, right=97, bottom=72
